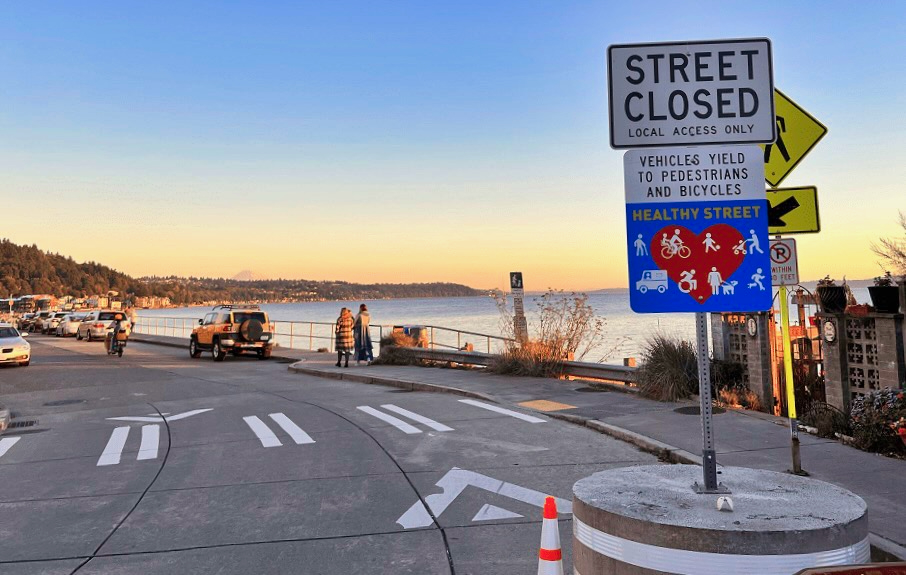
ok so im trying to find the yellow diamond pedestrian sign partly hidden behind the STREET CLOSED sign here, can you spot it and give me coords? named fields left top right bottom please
left=762, top=89, right=827, bottom=187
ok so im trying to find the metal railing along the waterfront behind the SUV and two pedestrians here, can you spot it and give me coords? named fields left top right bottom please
left=135, top=315, right=513, bottom=355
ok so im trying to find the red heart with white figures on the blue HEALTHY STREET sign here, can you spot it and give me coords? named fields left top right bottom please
left=651, top=224, right=746, bottom=303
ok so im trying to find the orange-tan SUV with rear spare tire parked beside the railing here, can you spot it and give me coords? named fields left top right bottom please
left=189, top=305, right=274, bottom=361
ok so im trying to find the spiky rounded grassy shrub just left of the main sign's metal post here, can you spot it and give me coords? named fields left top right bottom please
left=638, top=334, right=698, bottom=401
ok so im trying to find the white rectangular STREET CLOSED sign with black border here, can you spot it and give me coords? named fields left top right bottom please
left=607, top=38, right=777, bottom=149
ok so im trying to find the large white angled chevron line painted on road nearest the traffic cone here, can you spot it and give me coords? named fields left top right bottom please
left=396, top=467, right=573, bottom=529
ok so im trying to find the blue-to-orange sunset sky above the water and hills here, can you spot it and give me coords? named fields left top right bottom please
left=0, top=1, right=906, bottom=289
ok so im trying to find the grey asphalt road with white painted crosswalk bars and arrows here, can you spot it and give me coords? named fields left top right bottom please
left=0, top=336, right=654, bottom=575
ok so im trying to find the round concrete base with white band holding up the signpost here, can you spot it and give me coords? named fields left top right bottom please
left=573, top=465, right=870, bottom=575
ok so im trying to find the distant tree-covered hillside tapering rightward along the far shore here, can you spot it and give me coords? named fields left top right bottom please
left=0, top=239, right=484, bottom=305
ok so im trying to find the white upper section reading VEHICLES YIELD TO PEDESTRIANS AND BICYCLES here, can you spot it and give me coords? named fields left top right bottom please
left=623, top=146, right=767, bottom=204
